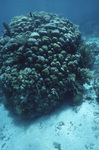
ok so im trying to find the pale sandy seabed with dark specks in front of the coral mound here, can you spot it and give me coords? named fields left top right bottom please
left=0, top=91, right=99, bottom=150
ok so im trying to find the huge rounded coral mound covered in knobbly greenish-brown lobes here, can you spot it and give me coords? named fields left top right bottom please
left=0, top=12, right=93, bottom=117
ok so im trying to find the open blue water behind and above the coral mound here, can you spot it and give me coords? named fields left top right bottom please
left=0, top=0, right=99, bottom=35
